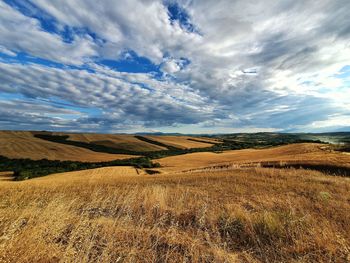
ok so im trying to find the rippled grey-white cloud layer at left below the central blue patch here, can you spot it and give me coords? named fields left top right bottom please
left=0, top=62, right=215, bottom=132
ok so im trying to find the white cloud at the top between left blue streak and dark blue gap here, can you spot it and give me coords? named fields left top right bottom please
left=33, top=0, right=199, bottom=64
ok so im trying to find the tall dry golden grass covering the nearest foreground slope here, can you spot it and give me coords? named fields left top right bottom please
left=0, top=167, right=350, bottom=262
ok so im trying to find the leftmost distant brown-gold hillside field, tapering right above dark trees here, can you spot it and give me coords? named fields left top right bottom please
left=0, top=131, right=135, bottom=162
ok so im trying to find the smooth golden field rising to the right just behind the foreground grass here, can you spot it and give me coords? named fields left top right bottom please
left=156, top=143, right=350, bottom=172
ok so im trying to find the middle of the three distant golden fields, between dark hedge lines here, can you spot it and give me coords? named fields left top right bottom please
left=67, top=133, right=166, bottom=152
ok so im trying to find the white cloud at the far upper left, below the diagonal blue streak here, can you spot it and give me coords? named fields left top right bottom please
left=0, top=2, right=97, bottom=65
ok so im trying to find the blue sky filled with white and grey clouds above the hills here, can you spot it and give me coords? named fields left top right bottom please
left=0, top=0, right=350, bottom=133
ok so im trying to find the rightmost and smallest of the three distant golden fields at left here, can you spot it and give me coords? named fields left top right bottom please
left=144, top=136, right=218, bottom=149
